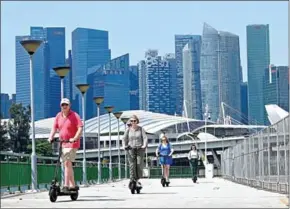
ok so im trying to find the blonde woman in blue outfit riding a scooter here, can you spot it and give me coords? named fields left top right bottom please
left=156, top=136, right=174, bottom=183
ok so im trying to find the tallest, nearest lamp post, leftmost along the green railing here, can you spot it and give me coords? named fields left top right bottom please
left=20, top=40, right=42, bottom=191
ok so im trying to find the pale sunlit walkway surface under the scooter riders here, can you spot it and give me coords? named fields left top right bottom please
left=1, top=178, right=287, bottom=208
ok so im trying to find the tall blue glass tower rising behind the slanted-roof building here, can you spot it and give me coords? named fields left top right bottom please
left=72, top=28, right=111, bottom=116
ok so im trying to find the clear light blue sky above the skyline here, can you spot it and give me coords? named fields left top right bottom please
left=1, top=1, right=288, bottom=94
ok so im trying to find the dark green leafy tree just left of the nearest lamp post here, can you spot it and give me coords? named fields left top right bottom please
left=8, top=104, right=30, bottom=153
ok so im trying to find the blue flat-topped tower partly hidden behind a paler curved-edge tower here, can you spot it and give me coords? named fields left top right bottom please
left=175, top=35, right=196, bottom=115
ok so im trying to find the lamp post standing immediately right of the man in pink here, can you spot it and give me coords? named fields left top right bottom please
left=76, top=84, right=90, bottom=186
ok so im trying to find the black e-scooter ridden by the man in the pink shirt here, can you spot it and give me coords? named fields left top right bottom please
left=48, top=140, right=79, bottom=202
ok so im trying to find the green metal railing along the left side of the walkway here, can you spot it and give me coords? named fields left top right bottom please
left=0, top=152, right=129, bottom=194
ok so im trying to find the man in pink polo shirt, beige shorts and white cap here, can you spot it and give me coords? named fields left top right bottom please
left=48, top=98, right=83, bottom=191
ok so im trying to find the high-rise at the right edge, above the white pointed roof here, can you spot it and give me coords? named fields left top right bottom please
left=263, top=65, right=289, bottom=125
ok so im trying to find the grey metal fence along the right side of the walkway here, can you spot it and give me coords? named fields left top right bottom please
left=221, top=116, right=290, bottom=194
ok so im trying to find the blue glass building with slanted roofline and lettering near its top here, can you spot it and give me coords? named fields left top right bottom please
left=86, top=54, right=130, bottom=119
